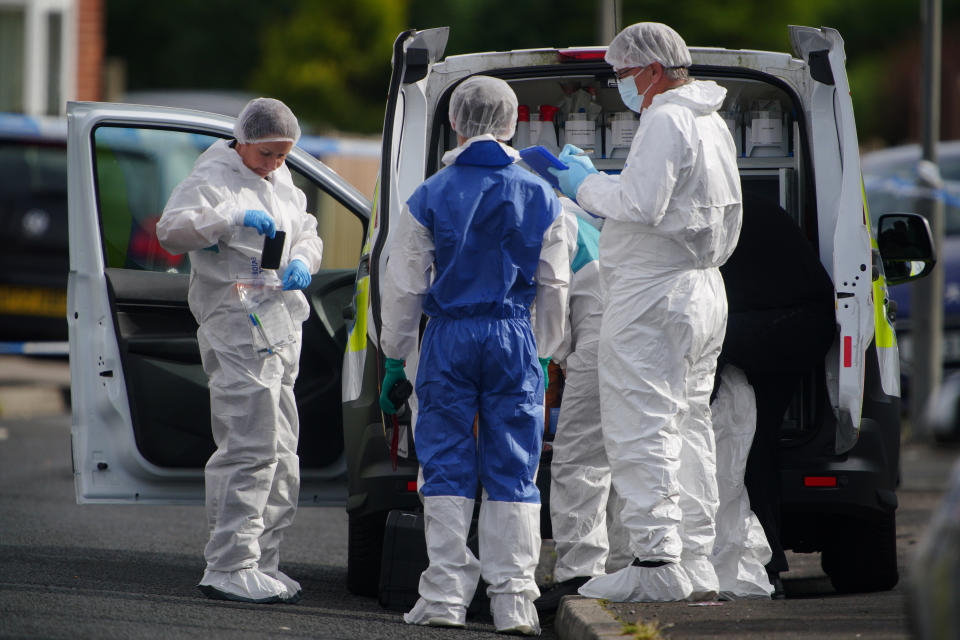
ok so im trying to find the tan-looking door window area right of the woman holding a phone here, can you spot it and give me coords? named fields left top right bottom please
left=287, top=169, right=363, bottom=269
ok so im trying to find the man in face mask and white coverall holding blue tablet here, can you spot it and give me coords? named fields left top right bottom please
left=551, top=22, right=741, bottom=601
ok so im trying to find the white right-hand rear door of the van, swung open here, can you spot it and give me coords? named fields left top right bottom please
left=790, top=26, right=884, bottom=453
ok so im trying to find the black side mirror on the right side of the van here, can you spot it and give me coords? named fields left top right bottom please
left=877, top=213, right=937, bottom=285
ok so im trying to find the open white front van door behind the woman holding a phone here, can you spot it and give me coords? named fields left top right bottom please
left=67, top=102, right=370, bottom=504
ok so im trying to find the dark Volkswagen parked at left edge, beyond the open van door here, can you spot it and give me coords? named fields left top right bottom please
left=0, top=113, right=68, bottom=344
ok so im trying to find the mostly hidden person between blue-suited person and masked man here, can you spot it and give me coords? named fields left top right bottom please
left=535, top=197, right=633, bottom=615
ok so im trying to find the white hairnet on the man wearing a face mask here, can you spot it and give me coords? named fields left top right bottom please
left=604, top=22, right=693, bottom=69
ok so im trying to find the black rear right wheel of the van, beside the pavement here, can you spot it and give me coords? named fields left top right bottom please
left=820, top=513, right=900, bottom=593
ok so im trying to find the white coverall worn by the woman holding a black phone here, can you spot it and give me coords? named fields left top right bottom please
left=157, top=140, right=323, bottom=592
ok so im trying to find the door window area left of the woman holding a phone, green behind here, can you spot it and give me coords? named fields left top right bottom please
left=93, top=126, right=217, bottom=273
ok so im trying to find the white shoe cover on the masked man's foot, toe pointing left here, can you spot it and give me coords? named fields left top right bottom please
left=579, top=563, right=693, bottom=602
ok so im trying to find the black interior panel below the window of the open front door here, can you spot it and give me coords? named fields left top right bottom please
left=106, top=269, right=354, bottom=469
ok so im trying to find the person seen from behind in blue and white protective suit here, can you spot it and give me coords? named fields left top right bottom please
left=380, top=76, right=570, bottom=635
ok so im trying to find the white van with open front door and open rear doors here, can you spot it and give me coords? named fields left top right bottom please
left=68, top=27, right=930, bottom=594
